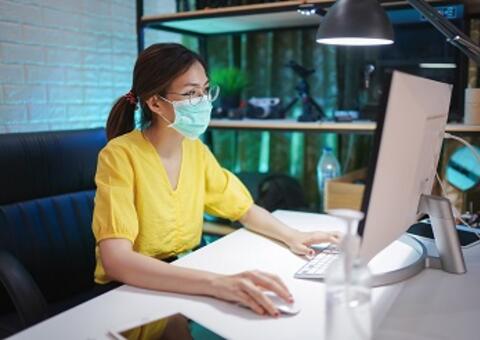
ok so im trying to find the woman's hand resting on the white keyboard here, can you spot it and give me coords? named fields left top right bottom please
left=287, top=231, right=342, bottom=257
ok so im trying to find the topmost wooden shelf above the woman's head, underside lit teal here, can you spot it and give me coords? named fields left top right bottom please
left=141, top=0, right=444, bottom=36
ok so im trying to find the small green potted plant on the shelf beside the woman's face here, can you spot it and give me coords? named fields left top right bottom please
left=210, top=67, right=248, bottom=110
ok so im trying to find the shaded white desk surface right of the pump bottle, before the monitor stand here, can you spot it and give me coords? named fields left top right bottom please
left=375, top=238, right=480, bottom=340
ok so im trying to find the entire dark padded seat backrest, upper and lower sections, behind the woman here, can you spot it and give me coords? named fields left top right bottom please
left=0, top=129, right=106, bottom=314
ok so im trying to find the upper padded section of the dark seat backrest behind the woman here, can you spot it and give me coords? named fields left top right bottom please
left=0, top=129, right=106, bottom=205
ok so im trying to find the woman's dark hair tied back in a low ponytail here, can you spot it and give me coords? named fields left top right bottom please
left=107, top=43, right=206, bottom=140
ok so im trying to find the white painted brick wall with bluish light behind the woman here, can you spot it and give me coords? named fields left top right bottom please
left=0, top=0, right=180, bottom=133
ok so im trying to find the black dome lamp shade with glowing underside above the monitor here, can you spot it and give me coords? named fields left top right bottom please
left=316, top=0, right=393, bottom=45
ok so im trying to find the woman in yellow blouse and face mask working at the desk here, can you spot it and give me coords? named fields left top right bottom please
left=93, top=44, right=338, bottom=315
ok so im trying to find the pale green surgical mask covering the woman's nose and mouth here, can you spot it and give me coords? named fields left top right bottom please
left=161, top=96, right=212, bottom=139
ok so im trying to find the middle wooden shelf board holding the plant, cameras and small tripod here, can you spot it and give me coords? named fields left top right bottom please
left=210, top=119, right=480, bottom=133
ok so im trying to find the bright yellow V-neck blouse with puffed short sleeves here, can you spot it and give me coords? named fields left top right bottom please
left=92, top=130, right=253, bottom=283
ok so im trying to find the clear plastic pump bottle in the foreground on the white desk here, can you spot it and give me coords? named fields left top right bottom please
left=325, top=210, right=372, bottom=340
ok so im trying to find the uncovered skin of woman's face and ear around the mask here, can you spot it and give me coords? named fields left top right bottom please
left=147, top=61, right=209, bottom=125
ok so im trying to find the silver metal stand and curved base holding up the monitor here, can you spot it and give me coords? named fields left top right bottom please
left=372, top=195, right=467, bottom=287
